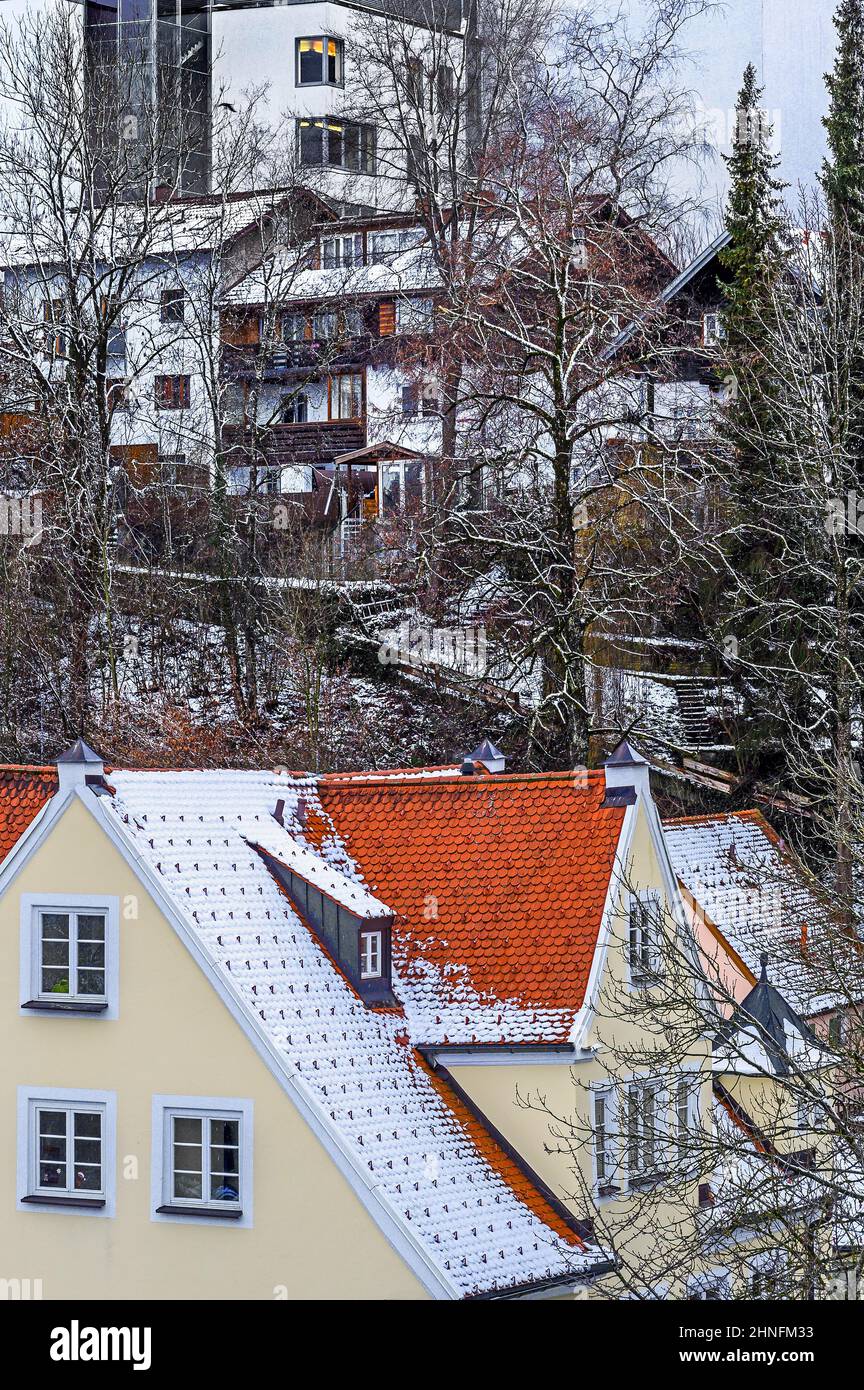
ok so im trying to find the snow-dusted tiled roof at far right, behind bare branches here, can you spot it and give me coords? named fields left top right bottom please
left=664, top=810, right=838, bottom=1016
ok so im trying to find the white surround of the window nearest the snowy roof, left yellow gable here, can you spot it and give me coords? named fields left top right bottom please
left=150, top=1095, right=253, bottom=1229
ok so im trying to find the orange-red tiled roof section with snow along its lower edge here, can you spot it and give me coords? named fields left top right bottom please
left=319, top=773, right=624, bottom=1044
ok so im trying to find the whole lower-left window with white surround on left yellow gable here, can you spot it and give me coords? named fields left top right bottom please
left=18, top=1086, right=117, bottom=1216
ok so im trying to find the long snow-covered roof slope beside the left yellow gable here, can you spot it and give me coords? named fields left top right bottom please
left=101, top=771, right=600, bottom=1298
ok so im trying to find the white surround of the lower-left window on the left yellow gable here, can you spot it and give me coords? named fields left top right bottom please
left=17, top=1086, right=117, bottom=1218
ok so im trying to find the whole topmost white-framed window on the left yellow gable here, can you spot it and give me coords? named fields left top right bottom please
left=21, top=894, right=119, bottom=1017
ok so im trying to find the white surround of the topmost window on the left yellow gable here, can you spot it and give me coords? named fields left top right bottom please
left=18, top=892, right=119, bottom=1019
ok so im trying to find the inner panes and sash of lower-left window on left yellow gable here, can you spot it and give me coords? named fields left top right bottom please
left=29, top=1101, right=104, bottom=1200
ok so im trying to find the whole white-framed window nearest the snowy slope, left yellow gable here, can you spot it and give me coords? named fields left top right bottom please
left=153, top=1095, right=251, bottom=1226
